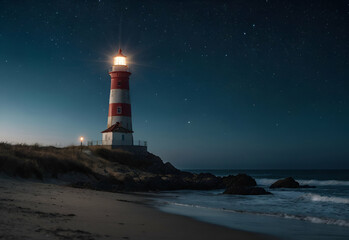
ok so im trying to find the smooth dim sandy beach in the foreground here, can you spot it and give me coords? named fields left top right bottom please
left=0, top=177, right=274, bottom=240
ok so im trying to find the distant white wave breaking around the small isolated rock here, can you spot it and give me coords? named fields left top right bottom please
left=256, top=178, right=349, bottom=186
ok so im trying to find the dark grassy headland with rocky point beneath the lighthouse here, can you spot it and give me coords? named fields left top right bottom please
left=0, top=143, right=270, bottom=194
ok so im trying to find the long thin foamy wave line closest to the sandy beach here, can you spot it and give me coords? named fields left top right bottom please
left=166, top=202, right=349, bottom=227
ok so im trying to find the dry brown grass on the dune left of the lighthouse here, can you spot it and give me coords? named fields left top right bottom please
left=0, top=142, right=92, bottom=179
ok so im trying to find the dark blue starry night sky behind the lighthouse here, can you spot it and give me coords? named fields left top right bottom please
left=0, top=0, right=349, bottom=169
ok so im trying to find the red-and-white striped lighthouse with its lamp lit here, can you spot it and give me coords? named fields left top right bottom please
left=102, top=49, right=133, bottom=148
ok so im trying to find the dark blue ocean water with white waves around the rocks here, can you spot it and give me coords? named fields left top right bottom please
left=154, top=170, right=349, bottom=240
